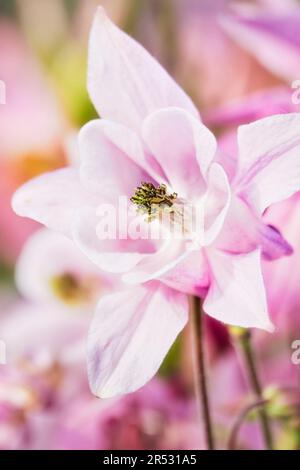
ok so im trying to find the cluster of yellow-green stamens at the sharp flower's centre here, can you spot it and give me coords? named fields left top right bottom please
left=130, top=182, right=177, bottom=222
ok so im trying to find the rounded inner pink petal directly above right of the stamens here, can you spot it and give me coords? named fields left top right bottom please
left=142, top=108, right=217, bottom=200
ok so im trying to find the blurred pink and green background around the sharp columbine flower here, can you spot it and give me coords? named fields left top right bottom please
left=0, top=0, right=300, bottom=449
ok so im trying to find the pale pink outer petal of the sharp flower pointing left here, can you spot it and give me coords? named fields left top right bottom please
left=12, top=168, right=95, bottom=235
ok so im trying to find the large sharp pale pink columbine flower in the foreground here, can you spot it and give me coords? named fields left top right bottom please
left=13, top=8, right=300, bottom=397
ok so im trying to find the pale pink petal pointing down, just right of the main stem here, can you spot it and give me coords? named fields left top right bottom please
left=203, top=250, right=274, bottom=332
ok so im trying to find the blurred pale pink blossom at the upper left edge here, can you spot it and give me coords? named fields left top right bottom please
left=0, top=23, right=65, bottom=159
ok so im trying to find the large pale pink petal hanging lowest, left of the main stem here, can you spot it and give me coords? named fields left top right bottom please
left=88, top=283, right=188, bottom=398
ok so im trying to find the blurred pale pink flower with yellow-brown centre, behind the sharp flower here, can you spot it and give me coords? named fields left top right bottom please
left=15, top=228, right=113, bottom=312
